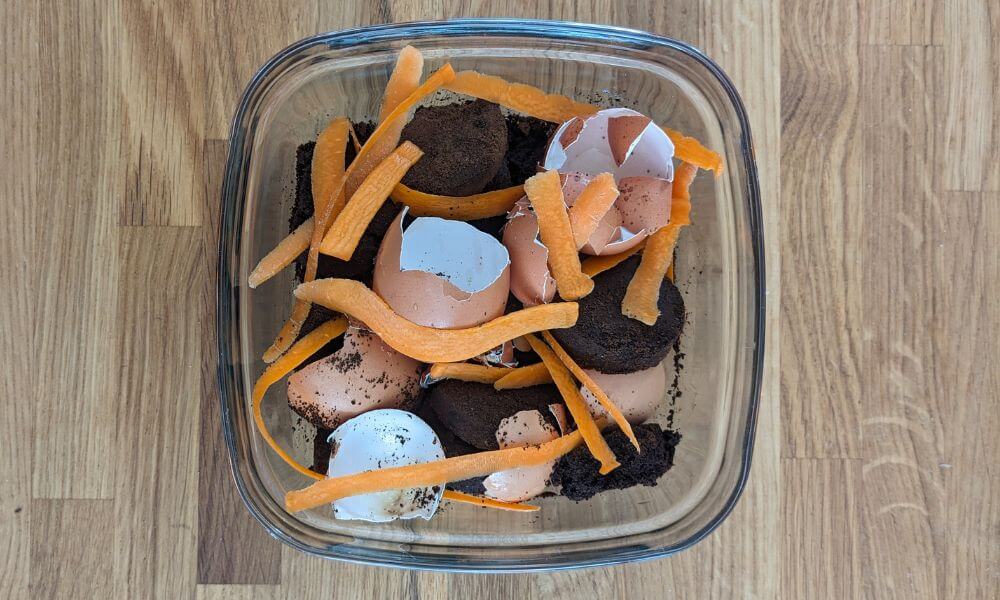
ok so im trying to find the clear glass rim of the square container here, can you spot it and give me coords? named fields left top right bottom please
left=216, top=18, right=766, bottom=573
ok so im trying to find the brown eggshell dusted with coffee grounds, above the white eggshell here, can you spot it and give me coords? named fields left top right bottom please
left=288, top=328, right=423, bottom=429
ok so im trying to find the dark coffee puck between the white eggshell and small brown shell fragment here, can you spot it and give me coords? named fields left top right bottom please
left=426, top=379, right=562, bottom=450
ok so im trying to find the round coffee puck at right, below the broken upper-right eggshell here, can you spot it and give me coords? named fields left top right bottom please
left=552, top=256, right=686, bottom=373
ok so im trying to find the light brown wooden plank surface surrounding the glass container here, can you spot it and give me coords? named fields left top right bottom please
left=0, top=0, right=1000, bottom=600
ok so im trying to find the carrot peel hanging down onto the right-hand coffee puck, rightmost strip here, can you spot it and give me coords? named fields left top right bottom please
left=622, top=163, right=697, bottom=326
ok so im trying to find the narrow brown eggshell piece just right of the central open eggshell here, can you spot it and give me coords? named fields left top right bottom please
left=503, top=202, right=556, bottom=306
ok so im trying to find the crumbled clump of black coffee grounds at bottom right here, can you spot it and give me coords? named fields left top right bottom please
left=550, top=423, right=681, bottom=501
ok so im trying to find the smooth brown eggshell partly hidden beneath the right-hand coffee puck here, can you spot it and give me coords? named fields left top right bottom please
left=580, top=365, right=667, bottom=425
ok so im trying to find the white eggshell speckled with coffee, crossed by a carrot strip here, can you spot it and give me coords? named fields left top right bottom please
left=327, top=409, right=444, bottom=523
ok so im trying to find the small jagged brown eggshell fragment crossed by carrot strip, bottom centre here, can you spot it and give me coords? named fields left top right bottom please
left=483, top=410, right=559, bottom=502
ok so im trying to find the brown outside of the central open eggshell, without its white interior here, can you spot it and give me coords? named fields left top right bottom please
left=372, top=211, right=510, bottom=329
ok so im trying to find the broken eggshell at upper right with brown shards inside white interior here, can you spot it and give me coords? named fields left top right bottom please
left=543, top=108, right=674, bottom=255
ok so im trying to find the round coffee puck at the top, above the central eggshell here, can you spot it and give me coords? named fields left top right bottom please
left=400, top=100, right=507, bottom=196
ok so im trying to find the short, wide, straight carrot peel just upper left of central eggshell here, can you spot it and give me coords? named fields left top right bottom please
left=319, top=142, right=424, bottom=260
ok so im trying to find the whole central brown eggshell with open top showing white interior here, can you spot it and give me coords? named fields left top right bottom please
left=372, top=209, right=510, bottom=329
